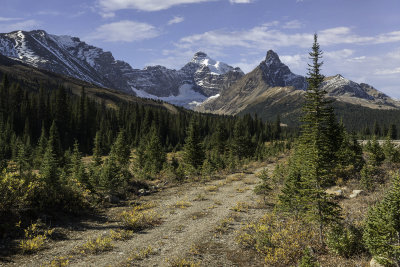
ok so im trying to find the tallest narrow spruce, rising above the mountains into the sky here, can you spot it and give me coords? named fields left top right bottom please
left=281, top=34, right=340, bottom=244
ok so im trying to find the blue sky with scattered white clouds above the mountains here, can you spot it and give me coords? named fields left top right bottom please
left=0, top=0, right=400, bottom=98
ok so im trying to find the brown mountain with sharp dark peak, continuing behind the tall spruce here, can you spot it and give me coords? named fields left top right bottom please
left=197, top=50, right=400, bottom=118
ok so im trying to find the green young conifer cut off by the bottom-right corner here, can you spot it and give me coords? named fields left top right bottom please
left=363, top=173, right=400, bottom=266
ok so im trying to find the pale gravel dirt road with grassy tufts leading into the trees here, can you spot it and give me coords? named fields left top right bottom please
left=5, top=164, right=273, bottom=267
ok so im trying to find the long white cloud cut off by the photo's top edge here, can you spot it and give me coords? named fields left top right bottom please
left=97, top=0, right=252, bottom=12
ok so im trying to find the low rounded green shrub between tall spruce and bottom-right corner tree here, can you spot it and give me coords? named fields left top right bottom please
left=326, top=225, right=364, bottom=258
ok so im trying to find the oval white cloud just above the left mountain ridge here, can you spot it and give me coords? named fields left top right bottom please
left=86, top=20, right=160, bottom=42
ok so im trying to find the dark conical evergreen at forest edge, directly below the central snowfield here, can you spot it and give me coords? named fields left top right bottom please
left=183, top=119, right=205, bottom=169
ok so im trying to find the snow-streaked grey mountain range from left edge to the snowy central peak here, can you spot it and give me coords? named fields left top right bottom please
left=0, top=30, right=244, bottom=108
